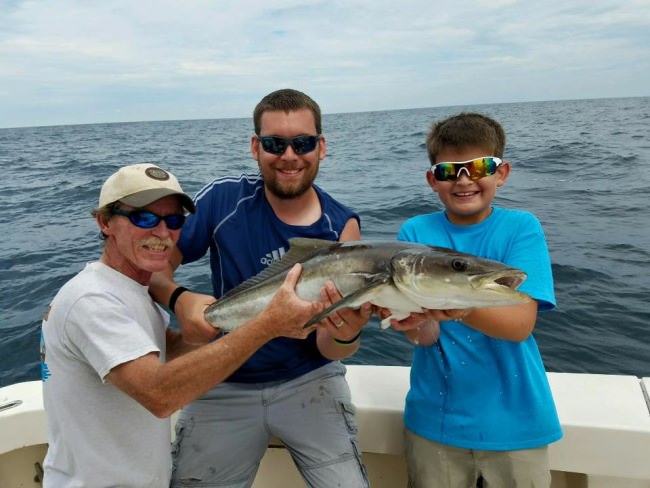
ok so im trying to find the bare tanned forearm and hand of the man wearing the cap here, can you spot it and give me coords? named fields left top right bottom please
left=106, top=265, right=324, bottom=418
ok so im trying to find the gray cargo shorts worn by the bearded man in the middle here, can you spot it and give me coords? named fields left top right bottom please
left=171, top=361, right=368, bottom=488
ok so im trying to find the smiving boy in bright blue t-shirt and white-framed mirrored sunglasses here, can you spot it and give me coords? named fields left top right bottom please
left=396, top=113, right=562, bottom=488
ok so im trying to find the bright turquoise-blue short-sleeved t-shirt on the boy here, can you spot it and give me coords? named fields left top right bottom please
left=398, top=208, right=562, bottom=451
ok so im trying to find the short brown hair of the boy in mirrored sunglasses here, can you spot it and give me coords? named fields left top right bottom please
left=427, top=112, right=506, bottom=164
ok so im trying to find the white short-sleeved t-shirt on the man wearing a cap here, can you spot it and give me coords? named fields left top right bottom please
left=41, top=262, right=171, bottom=488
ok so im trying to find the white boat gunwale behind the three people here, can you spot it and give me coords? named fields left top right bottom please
left=0, top=365, right=650, bottom=488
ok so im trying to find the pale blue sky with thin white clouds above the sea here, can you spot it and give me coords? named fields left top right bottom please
left=0, top=0, right=650, bottom=128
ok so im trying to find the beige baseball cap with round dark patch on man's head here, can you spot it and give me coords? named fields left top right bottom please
left=99, top=163, right=196, bottom=213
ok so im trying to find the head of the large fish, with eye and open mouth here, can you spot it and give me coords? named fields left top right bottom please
left=391, top=246, right=531, bottom=310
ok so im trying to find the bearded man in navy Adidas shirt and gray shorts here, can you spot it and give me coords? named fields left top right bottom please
left=152, top=89, right=371, bottom=488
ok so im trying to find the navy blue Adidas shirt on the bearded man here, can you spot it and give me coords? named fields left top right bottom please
left=178, top=174, right=359, bottom=383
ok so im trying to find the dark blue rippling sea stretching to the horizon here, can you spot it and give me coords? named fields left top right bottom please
left=0, top=97, right=650, bottom=386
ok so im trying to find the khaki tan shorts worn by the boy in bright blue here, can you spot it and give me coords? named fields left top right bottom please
left=404, top=429, right=551, bottom=488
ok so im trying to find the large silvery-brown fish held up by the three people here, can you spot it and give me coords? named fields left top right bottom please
left=205, top=238, right=530, bottom=332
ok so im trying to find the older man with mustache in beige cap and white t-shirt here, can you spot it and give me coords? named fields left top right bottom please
left=41, top=163, right=322, bottom=488
